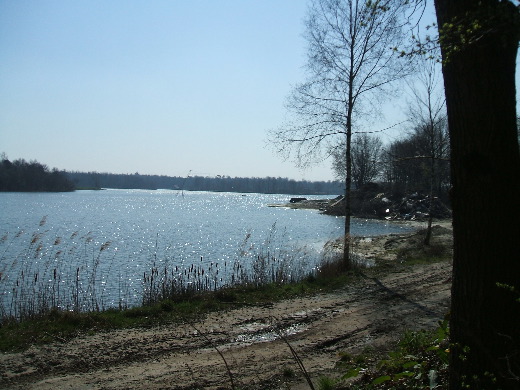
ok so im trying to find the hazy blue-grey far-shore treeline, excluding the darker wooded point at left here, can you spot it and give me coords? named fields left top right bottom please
left=67, top=172, right=345, bottom=195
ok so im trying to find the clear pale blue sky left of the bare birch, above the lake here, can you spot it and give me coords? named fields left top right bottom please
left=0, top=0, right=516, bottom=180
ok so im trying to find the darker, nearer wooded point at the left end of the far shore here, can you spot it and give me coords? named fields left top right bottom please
left=0, top=156, right=74, bottom=192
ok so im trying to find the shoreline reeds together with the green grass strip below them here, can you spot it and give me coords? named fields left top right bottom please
left=0, top=218, right=360, bottom=351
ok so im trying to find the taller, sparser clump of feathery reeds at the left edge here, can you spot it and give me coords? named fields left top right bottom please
left=0, top=217, right=121, bottom=322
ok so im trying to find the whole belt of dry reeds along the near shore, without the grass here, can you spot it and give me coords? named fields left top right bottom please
left=0, top=217, right=315, bottom=323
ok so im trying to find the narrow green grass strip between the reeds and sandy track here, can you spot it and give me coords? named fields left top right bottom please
left=0, top=260, right=358, bottom=352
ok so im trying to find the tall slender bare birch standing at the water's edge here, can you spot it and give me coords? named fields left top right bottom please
left=269, top=0, right=410, bottom=268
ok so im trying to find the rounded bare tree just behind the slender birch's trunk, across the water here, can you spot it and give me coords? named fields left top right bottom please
left=332, top=133, right=383, bottom=188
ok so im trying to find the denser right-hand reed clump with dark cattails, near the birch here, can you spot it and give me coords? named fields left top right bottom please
left=142, top=224, right=312, bottom=305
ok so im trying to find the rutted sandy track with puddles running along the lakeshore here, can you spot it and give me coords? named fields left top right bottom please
left=0, top=227, right=451, bottom=390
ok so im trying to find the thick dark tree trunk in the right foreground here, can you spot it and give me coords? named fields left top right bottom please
left=435, top=0, right=520, bottom=389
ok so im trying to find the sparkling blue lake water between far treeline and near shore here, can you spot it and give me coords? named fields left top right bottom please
left=0, top=190, right=407, bottom=316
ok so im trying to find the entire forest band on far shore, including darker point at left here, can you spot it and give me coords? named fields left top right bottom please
left=0, top=154, right=344, bottom=195
